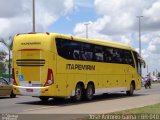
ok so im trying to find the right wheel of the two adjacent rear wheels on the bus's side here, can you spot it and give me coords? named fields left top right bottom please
left=85, top=84, right=94, bottom=100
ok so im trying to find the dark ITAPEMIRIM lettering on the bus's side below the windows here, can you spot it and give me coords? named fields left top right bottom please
left=66, top=64, right=96, bottom=70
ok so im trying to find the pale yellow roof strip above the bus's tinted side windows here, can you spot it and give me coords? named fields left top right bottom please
left=51, top=33, right=137, bottom=52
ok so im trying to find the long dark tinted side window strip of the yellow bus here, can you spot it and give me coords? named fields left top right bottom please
left=56, top=38, right=134, bottom=66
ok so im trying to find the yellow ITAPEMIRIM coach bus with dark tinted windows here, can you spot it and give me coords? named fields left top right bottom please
left=12, top=33, right=143, bottom=101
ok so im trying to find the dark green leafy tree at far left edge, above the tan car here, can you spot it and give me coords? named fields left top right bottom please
left=0, top=51, right=7, bottom=77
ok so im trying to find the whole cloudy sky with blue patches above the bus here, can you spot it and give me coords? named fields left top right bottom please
left=0, top=0, right=160, bottom=73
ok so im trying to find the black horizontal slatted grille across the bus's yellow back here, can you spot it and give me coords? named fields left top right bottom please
left=16, top=59, right=45, bottom=67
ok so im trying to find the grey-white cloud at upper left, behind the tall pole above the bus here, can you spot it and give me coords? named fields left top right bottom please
left=0, top=0, right=74, bottom=38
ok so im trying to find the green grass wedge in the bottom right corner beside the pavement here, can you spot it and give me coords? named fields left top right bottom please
left=84, top=103, right=160, bottom=120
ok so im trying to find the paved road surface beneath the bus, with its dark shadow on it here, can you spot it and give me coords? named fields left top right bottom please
left=0, top=84, right=160, bottom=119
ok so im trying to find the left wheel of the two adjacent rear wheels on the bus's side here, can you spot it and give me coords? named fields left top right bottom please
left=73, top=84, right=83, bottom=102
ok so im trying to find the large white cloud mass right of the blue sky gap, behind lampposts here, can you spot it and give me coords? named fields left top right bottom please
left=74, top=0, right=160, bottom=73
